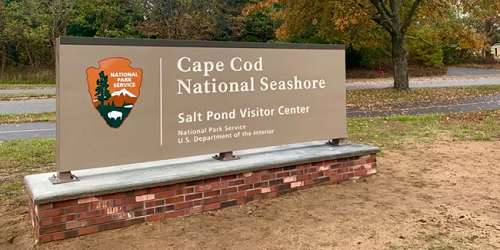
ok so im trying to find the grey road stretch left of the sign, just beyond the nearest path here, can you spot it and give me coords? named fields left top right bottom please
left=0, top=98, right=56, bottom=114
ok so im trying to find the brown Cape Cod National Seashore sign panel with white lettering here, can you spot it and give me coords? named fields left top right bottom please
left=57, top=37, right=346, bottom=171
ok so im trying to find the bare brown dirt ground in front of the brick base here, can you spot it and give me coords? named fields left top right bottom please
left=0, top=140, right=500, bottom=250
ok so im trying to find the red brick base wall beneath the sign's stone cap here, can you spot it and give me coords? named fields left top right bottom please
left=30, top=154, right=376, bottom=242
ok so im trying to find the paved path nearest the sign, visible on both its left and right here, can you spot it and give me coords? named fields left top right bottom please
left=0, top=95, right=500, bottom=141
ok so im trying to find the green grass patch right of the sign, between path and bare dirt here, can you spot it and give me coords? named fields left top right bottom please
left=348, top=110, right=500, bottom=149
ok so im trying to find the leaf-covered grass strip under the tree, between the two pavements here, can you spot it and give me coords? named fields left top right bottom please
left=347, top=85, right=500, bottom=110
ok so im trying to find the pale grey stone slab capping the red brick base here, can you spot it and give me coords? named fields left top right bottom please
left=24, top=141, right=379, bottom=204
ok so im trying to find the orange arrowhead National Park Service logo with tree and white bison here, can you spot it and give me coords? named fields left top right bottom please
left=87, top=57, right=142, bottom=128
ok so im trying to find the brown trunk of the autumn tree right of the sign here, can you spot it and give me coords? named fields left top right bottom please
left=392, top=34, right=410, bottom=89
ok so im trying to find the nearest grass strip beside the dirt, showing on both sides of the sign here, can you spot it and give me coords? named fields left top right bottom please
left=0, top=110, right=500, bottom=204
